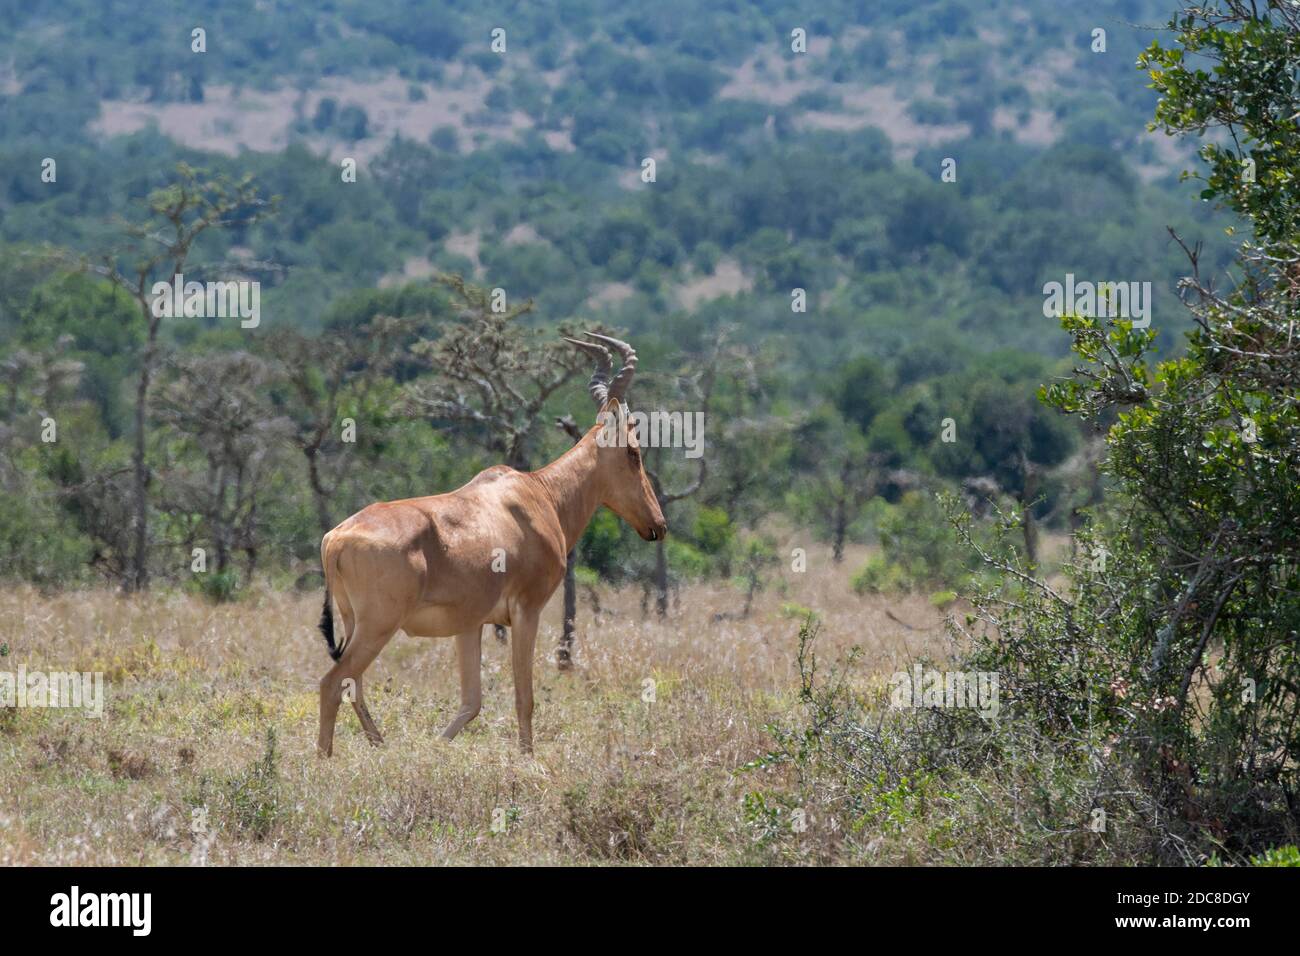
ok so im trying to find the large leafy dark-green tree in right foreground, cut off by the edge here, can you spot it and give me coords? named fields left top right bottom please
left=958, top=0, right=1300, bottom=862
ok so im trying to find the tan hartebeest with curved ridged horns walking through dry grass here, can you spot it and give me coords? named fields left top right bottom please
left=310, top=332, right=668, bottom=756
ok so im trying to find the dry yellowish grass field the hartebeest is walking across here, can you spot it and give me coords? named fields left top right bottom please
left=0, top=554, right=948, bottom=864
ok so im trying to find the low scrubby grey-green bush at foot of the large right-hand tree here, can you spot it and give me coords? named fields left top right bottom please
left=742, top=622, right=1162, bottom=865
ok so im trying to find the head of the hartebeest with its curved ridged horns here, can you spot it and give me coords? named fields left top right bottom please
left=566, top=332, right=668, bottom=541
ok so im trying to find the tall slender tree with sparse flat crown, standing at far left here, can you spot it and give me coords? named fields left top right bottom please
left=82, top=163, right=273, bottom=592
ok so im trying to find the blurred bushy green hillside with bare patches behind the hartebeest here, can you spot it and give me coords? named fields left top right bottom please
left=0, top=0, right=1230, bottom=596
